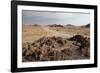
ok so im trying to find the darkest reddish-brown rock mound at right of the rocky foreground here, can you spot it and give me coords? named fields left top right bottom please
left=69, top=35, right=90, bottom=57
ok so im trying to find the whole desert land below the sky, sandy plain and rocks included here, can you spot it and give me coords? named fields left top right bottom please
left=22, top=24, right=90, bottom=62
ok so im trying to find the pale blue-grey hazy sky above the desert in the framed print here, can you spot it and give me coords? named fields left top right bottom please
left=22, top=10, right=90, bottom=26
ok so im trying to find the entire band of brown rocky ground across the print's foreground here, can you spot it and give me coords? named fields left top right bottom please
left=22, top=35, right=90, bottom=62
